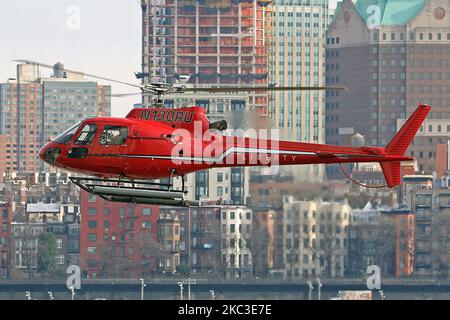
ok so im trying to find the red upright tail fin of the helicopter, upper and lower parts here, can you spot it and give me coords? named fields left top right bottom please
left=380, top=104, right=431, bottom=188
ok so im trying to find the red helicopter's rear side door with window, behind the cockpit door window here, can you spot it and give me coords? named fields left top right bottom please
left=98, top=125, right=128, bottom=175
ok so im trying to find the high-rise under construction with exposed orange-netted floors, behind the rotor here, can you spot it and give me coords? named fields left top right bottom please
left=141, top=0, right=271, bottom=204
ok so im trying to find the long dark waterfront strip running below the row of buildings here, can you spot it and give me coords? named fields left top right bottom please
left=0, top=280, right=450, bottom=300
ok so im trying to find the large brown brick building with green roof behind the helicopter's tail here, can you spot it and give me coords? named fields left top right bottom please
left=325, top=0, right=450, bottom=178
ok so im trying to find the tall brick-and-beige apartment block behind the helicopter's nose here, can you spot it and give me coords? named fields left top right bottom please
left=0, top=63, right=111, bottom=173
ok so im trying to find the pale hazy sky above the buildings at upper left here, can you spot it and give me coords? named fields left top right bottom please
left=0, top=0, right=338, bottom=116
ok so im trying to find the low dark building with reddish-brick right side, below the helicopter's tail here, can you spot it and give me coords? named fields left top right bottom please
left=346, top=202, right=415, bottom=278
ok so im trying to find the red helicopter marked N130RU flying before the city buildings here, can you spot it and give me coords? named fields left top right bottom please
left=22, top=60, right=431, bottom=206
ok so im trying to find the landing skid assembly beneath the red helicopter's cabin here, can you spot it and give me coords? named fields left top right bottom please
left=70, top=177, right=200, bottom=207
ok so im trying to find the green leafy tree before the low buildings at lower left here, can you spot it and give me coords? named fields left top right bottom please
left=37, top=232, right=57, bottom=274
